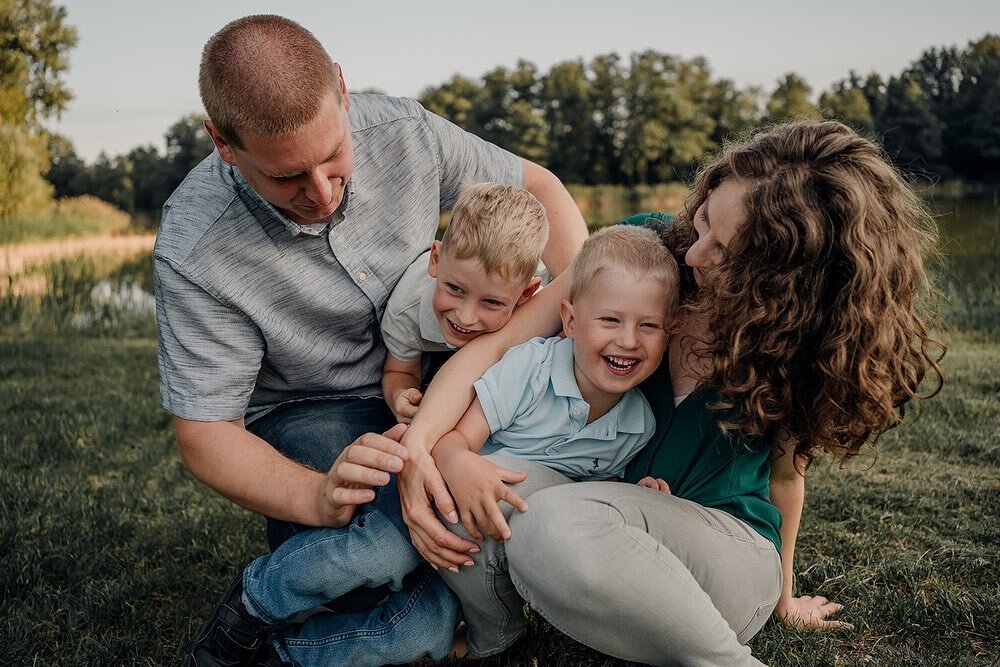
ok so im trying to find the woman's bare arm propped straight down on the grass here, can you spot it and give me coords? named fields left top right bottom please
left=771, top=443, right=854, bottom=630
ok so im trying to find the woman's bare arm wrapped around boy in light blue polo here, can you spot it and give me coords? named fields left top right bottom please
left=399, top=273, right=569, bottom=567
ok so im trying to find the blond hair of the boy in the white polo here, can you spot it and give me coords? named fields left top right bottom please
left=441, top=183, right=549, bottom=280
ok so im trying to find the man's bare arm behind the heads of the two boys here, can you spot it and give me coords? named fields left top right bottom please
left=520, top=158, right=587, bottom=278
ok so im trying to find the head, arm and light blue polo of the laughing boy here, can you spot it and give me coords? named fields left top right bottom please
left=432, top=226, right=678, bottom=548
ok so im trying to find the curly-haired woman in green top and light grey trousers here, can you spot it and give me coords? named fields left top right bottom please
left=401, top=117, right=941, bottom=665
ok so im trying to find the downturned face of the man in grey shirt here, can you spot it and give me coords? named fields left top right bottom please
left=206, top=91, right=354, bottom=225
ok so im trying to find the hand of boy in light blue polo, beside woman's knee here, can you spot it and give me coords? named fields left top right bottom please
left=439, top=451, right=528, bottom=542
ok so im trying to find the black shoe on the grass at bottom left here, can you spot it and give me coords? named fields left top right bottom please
left=184, top=571, right=274, bottom=667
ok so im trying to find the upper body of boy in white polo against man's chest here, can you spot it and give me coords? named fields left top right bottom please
left=382, top=183, right=549, bottom=424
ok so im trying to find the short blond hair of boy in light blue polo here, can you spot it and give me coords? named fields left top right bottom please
left=569, top=225, right=680, bottom=315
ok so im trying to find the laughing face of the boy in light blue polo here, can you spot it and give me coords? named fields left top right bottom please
left=561, top=269, right=670, bottom=405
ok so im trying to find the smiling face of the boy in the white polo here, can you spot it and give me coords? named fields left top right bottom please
left=427, top=241, right=541, bottom=347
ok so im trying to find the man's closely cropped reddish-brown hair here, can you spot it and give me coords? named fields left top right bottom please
left=198, top=14, right=343, bottom=148
